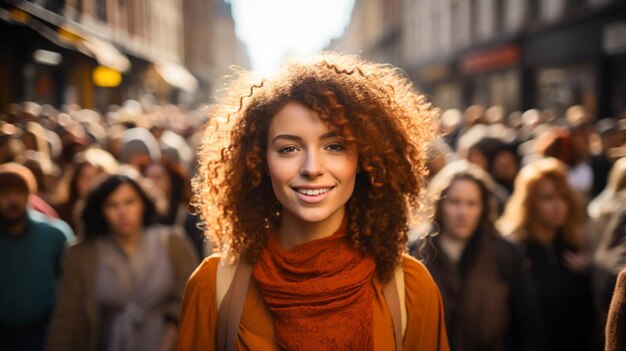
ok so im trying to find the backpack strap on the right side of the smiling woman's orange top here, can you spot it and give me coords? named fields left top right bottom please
left=383, top=265, right=407, bottom=351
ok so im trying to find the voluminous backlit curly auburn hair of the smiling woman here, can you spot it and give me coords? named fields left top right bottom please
left=192, top=53, right=438, bottom=281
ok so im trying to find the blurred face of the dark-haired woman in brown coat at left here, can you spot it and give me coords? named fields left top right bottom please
left=102, top=183, right=144, bottom=237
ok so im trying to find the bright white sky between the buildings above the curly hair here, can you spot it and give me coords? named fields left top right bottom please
left=230, top=0, right=354, bottom=72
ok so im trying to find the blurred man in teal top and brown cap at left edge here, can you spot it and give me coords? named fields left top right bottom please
left=0, top=163, right=67, bottom=351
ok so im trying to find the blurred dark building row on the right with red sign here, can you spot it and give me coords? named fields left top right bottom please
left=336, top=0, right=626, bottom=118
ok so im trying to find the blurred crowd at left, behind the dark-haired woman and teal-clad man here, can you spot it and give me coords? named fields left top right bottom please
left=0, top=99, right=206, bottom=256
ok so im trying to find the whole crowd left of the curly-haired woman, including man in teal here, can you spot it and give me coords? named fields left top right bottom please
left=0, top=101, right=211, bottom=350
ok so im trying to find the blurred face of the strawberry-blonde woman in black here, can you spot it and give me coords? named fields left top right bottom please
left=531, top=178, right=569, bottom=230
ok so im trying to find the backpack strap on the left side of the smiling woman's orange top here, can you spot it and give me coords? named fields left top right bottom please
left=216, top=257, right=252, bottom=351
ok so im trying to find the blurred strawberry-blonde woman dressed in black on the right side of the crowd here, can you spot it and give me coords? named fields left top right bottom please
left=498, top=158, right=593, bottom=350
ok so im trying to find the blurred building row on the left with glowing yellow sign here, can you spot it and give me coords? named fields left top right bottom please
left=0, top=0, right=245, bottom=110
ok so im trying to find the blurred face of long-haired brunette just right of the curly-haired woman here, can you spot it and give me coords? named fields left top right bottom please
left=440, top=179, right=483, bottom=240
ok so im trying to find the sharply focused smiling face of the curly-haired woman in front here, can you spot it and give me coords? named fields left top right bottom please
left=266, top=102, right=357, bottom=231
